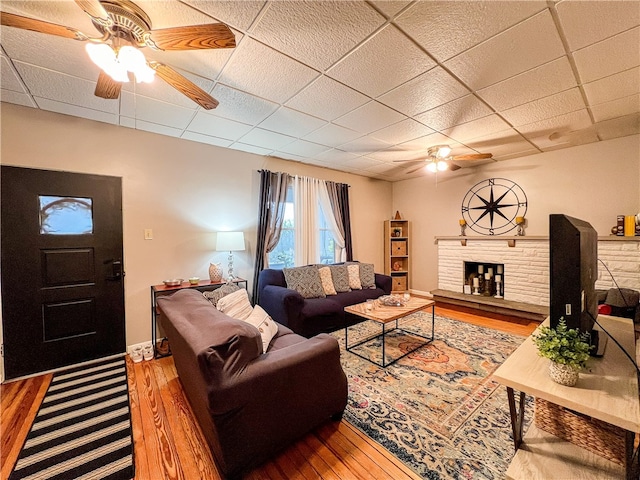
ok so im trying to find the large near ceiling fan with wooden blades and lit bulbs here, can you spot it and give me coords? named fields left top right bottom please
left=0, top=0, right=236, bottom=110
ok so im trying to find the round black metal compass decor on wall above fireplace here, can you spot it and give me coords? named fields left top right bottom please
left=462, top=178, right=527, bottom=235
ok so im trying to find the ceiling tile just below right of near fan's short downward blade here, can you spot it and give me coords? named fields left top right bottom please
left=120, top=92, right=195, bottom=130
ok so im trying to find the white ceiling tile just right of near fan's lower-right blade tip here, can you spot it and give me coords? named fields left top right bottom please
left=211, top=83, right=278, bottom=125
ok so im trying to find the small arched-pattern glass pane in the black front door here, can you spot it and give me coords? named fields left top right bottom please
left=39, top=195, right=93, bottom=235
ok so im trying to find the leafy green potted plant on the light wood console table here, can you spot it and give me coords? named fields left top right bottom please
left=533, top=318, right=592, bottom=387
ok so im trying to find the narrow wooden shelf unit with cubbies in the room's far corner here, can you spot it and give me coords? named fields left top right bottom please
left=384, top=220, right=411, bottom=292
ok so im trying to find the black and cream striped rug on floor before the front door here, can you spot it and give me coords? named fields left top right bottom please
left=9, top=358, right=134, bottom=480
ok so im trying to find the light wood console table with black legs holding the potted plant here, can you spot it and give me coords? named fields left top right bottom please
left=494, top=315, right=640, bottom=480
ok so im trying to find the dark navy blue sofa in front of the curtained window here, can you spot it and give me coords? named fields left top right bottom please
left=258, top=268, right=392, bottom=338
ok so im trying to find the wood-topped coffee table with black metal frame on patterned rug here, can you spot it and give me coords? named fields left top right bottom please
left=344, top=297, right=436, bottom=368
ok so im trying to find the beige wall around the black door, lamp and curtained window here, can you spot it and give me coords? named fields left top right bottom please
left=0, top=103, right=391, bottom=345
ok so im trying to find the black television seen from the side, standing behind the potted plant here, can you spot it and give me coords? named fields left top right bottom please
left=549, top=214, right=606, bottom=355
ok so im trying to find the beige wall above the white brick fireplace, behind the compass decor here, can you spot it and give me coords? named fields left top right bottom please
left=393, top=135, right=640, bottom=292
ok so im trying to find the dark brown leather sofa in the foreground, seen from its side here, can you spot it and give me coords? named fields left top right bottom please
left=158, top=290, right=347, bottom=478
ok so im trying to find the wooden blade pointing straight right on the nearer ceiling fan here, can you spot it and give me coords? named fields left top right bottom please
left=145, top=23, right=236, bottom=50
